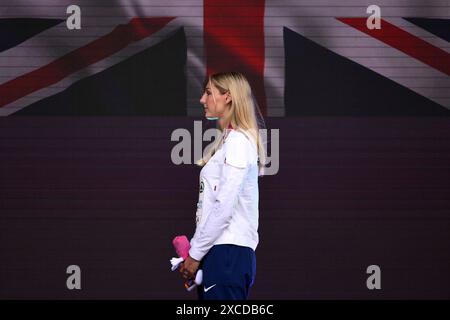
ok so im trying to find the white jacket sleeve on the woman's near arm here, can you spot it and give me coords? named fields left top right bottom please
left=189, top=134, right=247, bottom=261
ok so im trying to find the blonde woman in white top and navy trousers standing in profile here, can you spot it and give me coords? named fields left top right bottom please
left=180, top=72, right=265, bottom=300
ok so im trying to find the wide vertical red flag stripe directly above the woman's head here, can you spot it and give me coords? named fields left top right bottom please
left=203, top=0, right=266, bottom=115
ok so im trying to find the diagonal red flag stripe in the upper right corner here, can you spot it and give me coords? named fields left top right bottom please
left=336, top=18, right=450, bottom=75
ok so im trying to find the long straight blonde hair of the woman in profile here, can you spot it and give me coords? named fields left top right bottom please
left=196, top=71, right=266, bottom=173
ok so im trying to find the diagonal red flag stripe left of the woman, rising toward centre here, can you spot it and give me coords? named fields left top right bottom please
left=0, top=17, right=175, bottom=107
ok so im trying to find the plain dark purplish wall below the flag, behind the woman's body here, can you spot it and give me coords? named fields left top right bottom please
left=0, top=117, right=450, bottom=299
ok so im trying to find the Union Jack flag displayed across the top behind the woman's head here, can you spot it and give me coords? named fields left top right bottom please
left=0, top=0, right=450, bottom=116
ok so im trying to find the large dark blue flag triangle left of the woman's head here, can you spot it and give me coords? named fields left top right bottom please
left=13, top=28, right=187, bottom=116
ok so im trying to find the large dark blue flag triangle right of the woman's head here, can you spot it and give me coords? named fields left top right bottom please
left=284, top=28, right=450, bottom=116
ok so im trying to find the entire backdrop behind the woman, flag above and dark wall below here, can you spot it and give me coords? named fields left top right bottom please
left=0, top=0, right=450, bottom=298
